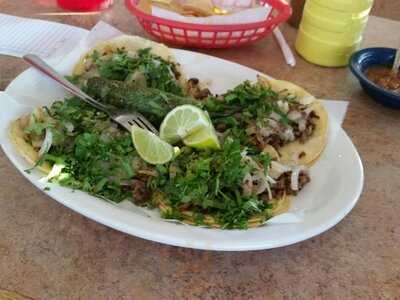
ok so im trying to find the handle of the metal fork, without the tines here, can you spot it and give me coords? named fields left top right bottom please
left=22, top=54, right=110, bottom=115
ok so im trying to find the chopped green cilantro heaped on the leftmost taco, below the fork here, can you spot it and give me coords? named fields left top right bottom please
left=36, top=98, right=146, bottom=202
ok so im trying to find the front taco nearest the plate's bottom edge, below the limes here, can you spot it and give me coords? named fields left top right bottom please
left=149, top=137, right=310, bottom=228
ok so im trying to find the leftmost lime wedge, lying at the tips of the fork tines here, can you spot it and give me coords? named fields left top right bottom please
left=132, top=126, right=177, bottom=165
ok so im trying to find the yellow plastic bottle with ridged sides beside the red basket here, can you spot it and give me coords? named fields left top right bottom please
left=295, top=0, right=373, bottom=67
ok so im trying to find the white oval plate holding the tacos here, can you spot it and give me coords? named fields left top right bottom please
left=0, top=50, right=364, bottom=251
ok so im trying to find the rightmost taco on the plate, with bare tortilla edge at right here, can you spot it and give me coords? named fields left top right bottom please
left=202, top=77, right=328, bottom=166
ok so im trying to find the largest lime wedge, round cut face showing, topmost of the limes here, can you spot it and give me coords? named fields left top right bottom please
left=160, top=105, right=212, bottom=144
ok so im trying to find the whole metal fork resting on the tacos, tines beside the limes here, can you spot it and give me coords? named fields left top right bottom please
left=23, top=54, right=158, bottom=135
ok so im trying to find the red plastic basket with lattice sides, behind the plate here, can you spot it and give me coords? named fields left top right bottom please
left=125, top=0, right=292, bottom=48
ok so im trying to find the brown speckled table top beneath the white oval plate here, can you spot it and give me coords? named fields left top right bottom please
left=0, top=0, right=400, bottom=300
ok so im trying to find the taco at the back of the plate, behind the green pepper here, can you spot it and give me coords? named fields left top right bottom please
left=72, top=35, right=187, bottom=94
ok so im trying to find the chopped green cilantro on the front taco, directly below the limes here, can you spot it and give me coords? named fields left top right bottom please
left=152, top=138, right=270, bottom=228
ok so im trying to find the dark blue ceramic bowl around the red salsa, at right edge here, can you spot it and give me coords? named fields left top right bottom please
left=349, top=48, right=400, bottom=108
